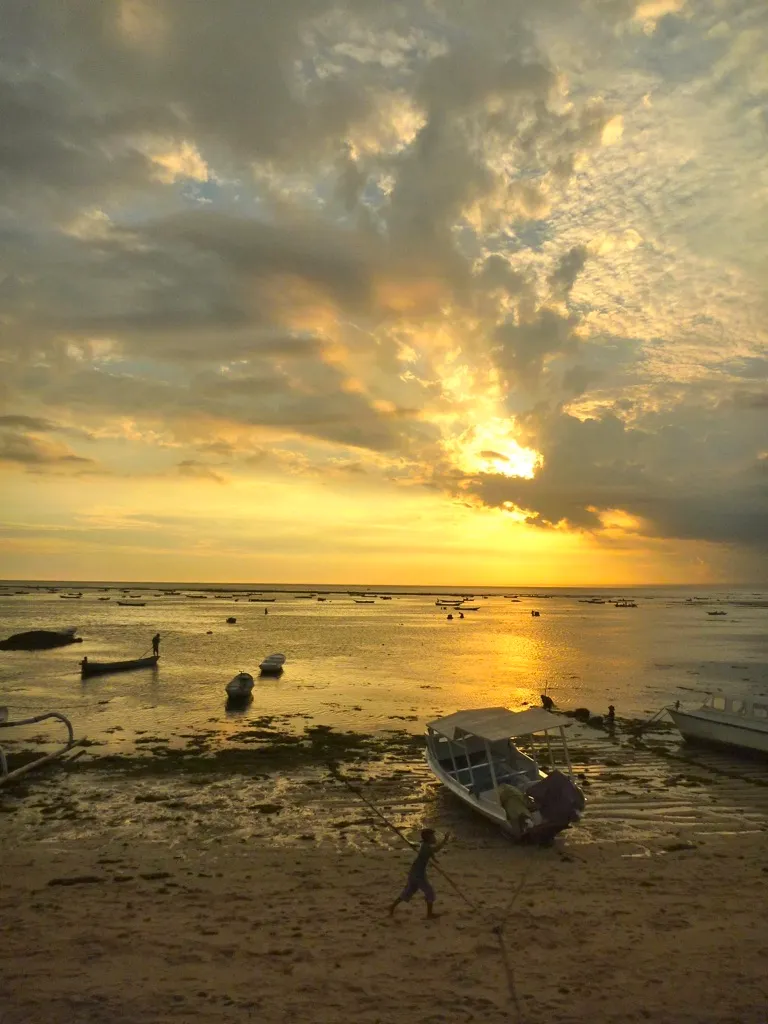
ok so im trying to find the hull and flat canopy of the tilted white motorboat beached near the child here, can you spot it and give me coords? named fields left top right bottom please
left=426, top=708, right=584, bottom=827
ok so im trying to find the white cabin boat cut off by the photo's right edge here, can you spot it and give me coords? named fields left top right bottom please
left=667, top=693, right=768, bottom=754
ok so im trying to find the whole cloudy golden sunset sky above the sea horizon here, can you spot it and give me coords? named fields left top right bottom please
left=0, top=0, right=768, bottom=586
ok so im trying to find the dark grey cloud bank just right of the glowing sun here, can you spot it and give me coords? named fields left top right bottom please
left=472, top=411, right=768, bottom=548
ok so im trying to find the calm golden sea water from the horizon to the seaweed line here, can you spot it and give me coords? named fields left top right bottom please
left=0, top=583, right=768, bottom=750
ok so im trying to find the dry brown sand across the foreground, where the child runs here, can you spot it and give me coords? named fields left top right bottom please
left=0, top=833, right=768, bottom=1024
